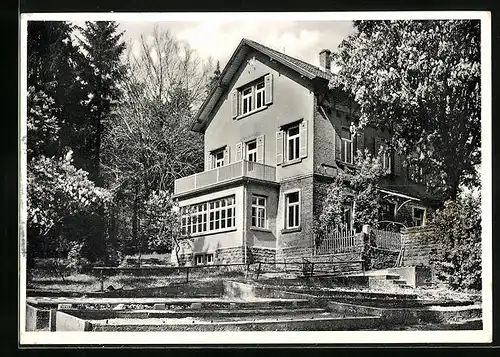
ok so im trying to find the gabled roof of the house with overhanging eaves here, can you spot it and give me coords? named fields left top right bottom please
left=191, top=38, right=334, bottom=132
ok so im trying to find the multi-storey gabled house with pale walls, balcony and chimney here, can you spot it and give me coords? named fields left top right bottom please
left=172, top=39, right=434, bottom=265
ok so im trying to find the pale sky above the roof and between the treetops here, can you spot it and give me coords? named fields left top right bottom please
left=118, top=19, right=353, bottom=69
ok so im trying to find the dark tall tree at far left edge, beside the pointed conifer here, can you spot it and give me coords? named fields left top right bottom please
left=27, top=21, right=84, bottom=159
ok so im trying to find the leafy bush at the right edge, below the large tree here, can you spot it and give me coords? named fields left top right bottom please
left=431, top=195, right=481, bottom=290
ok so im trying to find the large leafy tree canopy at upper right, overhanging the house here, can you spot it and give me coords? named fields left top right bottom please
left=330, top=20, right=481, bottom=198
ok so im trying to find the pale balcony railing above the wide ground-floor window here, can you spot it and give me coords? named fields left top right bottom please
left=174, top=160, right=276, bottom=195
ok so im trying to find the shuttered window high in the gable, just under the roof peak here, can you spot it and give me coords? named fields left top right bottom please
left=231, top=74, right=273, bottom=118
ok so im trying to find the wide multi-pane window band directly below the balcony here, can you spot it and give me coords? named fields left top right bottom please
left=181, top=196, right=236, bottom=235
